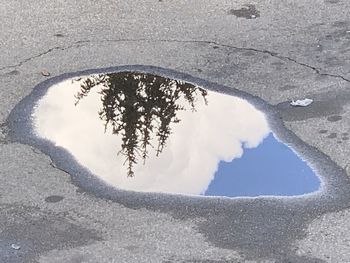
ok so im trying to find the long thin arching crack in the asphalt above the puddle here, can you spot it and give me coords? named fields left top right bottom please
left=0, top=38, right=350, bottom=83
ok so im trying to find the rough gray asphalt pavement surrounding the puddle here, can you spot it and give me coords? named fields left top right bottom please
left=0, top=0, right=350, bottom=262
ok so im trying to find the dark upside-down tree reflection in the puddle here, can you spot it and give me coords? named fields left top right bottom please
left=76, top=72, right=207, bottom=177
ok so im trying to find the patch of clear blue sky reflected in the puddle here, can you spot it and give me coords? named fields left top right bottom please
left=205, top=133, right=320, bottom=196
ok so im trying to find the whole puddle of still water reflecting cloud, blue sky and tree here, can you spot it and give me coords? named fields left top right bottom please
left=33, top=72, right=320, bottom=196
